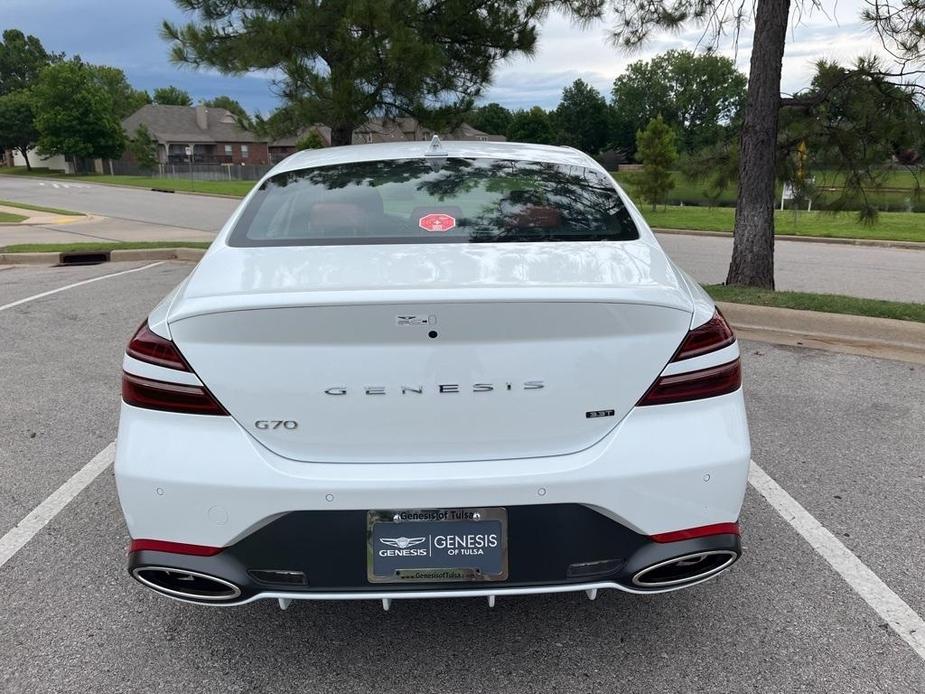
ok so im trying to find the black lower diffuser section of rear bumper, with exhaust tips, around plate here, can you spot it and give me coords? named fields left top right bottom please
left=129, top=504, right=741, bottom=605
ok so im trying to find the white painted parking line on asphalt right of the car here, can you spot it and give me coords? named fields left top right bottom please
left=748, top=460, right=925, bottom=660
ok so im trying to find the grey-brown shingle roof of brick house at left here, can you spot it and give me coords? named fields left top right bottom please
left=122, top=104, right=266, bottom=144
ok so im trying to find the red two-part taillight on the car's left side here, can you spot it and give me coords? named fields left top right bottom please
left=122, top=321, right=228, bottom=416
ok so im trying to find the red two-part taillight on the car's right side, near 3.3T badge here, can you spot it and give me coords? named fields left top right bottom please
left=637, top=310, right=742, bottom=405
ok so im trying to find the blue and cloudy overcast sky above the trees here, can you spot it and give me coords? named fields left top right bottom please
left=0, top=0, right=879, bottom=113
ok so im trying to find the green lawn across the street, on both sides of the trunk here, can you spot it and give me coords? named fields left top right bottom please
left=640, top=206, right=925, bottom=241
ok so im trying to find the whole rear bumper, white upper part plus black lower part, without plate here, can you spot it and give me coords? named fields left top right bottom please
left=115, top=391, right=750, bottom=604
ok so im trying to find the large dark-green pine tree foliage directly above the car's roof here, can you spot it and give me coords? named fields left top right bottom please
left=163, top=0, right=556, bottom=145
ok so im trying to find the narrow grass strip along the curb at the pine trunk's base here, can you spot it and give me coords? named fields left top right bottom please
left=704, top=284, right=925, bottom=323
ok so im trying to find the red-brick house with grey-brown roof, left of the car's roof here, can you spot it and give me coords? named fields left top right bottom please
left=122, top=104, right=270, bottom=165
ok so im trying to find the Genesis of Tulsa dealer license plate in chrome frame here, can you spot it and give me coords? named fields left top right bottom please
left=366, top=508, right=507, bottom=583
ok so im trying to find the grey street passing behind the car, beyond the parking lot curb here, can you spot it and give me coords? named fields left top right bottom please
left=0, top=176, right=925, bottom=302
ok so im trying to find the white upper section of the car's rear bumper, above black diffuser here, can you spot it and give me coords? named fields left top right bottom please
left=115, top=391, right=750, bottom=547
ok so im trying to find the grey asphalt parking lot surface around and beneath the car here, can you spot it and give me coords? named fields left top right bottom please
left=0, top=263, right=925, bottom=694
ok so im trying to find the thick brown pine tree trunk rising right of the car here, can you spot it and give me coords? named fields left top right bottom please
left=726, top=0, right=790, bottom=289
